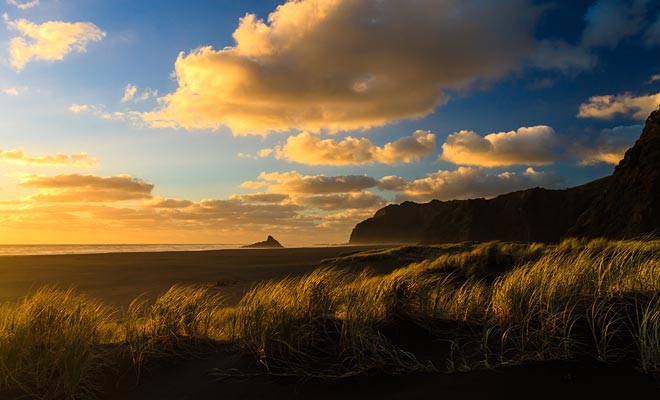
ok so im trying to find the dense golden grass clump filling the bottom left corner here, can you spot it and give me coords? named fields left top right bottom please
left=0, top=288, right=114, bottom=399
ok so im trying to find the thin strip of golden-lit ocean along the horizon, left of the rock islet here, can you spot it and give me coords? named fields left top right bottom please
left=0, top=244, right=241, bottom=256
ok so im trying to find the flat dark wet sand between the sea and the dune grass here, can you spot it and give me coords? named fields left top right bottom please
left=0, top=246, right=387, bottom=309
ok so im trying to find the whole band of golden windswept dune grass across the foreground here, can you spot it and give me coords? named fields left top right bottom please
left=0, top=239, right=660, bottom=399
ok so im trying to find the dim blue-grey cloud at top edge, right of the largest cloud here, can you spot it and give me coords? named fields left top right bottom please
left=582, top=0, right=649, bottom=47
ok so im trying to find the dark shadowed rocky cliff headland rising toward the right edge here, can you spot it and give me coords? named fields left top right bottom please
left=350, top=110, right=660, bottom=243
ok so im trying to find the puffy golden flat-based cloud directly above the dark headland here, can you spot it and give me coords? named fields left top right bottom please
left=440, top=125, right=557, bottom=167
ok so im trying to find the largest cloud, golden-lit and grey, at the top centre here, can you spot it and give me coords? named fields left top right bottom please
left=142, top=0, right=538, bottom=135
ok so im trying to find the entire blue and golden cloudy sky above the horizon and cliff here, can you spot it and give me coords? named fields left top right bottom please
left=0, top=0, right=660, bottom=246
